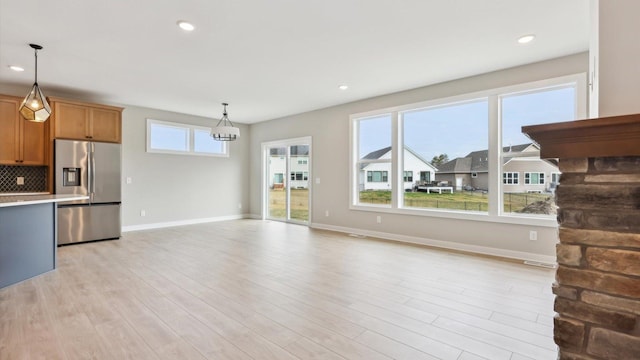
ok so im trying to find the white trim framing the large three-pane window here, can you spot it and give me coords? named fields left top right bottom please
left=349, top=73, right=588, bottom=227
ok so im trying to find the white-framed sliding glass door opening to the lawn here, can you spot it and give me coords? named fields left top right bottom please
left=262, top=138, right=311, bottom=223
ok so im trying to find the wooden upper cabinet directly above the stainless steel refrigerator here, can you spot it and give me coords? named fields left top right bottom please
left=49, top=98, right=122, bottom=143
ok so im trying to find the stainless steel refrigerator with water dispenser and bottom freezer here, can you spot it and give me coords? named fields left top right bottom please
left=54, top=140, right=121, bottom=245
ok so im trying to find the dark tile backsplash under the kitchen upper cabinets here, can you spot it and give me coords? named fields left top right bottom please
left=0, top=165, right=47, bottom=193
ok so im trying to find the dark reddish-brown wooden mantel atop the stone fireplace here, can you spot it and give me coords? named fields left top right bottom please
left=522, top=114, right=640, bottom=158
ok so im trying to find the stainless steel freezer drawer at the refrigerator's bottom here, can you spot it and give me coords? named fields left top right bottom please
left=58, top=204, right=121, bottom=245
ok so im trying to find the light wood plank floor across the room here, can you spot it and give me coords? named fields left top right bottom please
left=0, top=220, right=557, bottom=360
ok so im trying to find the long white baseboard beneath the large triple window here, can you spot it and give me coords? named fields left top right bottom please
left=310, top=223, right=556, bottom=264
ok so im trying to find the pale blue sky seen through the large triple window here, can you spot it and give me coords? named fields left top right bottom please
left=359, top=87, right=576, bottom=161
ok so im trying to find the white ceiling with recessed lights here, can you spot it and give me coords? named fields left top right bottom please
left=0, top=0, right=589, bottom=123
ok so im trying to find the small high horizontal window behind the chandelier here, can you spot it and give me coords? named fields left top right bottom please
left=147, top=119, right=229, bottom=156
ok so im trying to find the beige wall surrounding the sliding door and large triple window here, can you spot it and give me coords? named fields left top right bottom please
left=250, top=53, right=588, bottom=261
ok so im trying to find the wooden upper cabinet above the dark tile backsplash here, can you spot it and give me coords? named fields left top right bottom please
left=0, top=95, right=47, bottom=165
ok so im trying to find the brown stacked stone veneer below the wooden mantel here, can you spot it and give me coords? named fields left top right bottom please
left=553, top=156, right=640, bottom=360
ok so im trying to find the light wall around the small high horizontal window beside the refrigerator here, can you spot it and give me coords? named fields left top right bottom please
left=122, top=105, right=250, bottom=230
